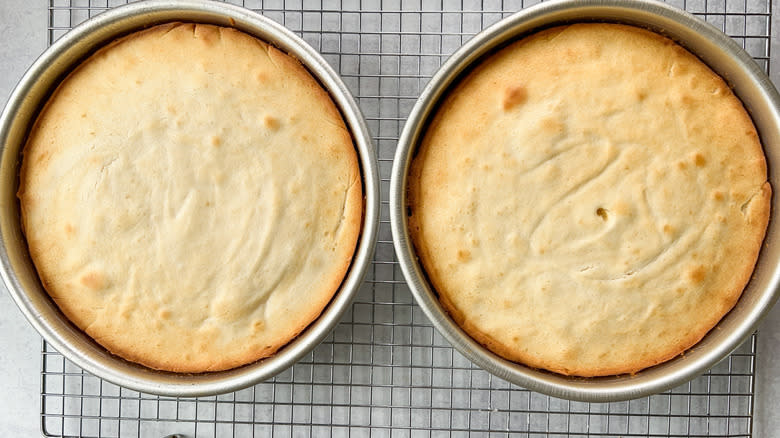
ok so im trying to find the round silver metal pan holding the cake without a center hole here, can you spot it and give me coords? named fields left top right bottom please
left=0, top=0, right=379, bottom=396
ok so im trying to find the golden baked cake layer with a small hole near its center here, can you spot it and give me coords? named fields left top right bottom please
left=408, top=24, right=771, bottom=376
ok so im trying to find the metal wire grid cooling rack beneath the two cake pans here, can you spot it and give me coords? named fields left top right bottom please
left=41, top=0, right=772, bottom=437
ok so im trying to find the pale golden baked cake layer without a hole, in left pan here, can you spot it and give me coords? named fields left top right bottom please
left=19, top=24, right=363, bottom=372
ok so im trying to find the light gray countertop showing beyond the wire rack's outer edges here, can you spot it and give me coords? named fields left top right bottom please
left=0, top=0, right=780, bottom=437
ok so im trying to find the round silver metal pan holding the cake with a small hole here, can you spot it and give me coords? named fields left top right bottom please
left=390, top=0, right=780, bottom=402
